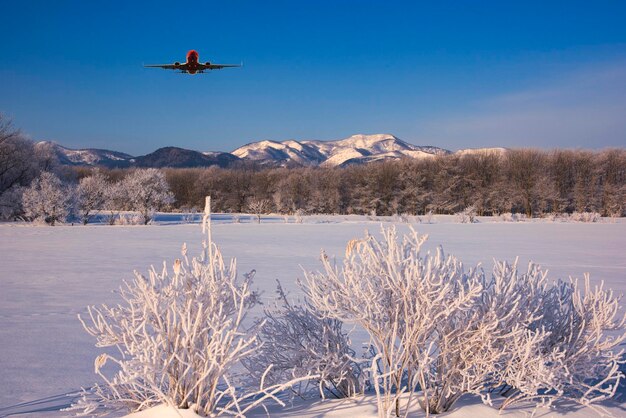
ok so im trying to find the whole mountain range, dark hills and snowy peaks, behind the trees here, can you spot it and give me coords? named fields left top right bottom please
left=36, top=134, right=505, bottom=168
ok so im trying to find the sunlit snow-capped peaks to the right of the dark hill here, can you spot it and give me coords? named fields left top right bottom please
left=232, top=134, right=450, bottom=167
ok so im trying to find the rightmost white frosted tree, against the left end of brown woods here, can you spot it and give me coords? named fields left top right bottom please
left=121, top=168, right=174, bottom=225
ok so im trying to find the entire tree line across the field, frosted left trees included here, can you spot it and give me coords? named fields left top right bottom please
left=0, top=114, right=626, bottom=222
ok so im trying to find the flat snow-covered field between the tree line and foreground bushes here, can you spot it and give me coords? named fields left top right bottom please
left=0, top=215, right=626, bottom=417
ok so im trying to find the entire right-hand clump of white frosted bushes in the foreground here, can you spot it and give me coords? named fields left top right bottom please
left=304, top=228, right=626, bottom=417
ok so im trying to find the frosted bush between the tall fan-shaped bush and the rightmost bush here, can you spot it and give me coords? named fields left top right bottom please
left=414, top=262, right=546, bottom=413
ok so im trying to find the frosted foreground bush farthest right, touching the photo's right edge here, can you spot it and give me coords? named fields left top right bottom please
left=494, top=275, right=626, bottom=409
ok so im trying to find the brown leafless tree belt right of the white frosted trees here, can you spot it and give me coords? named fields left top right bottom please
left=165, top=149, right=626, bottom=216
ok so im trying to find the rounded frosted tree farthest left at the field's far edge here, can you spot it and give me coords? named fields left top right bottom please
left=22, top=172, right=72, bottom=225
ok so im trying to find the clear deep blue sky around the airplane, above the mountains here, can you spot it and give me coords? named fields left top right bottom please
left=0, top=0, right=626, bottom=155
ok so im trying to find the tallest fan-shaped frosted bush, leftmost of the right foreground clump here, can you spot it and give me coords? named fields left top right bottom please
left=304, top=228, right=481, bottom=416
